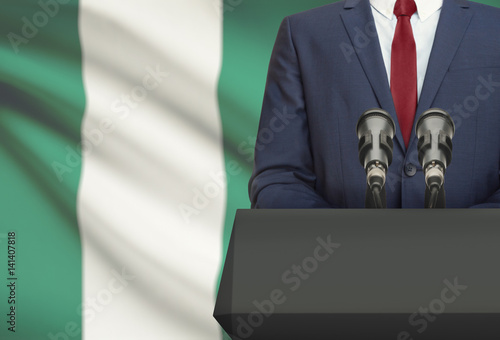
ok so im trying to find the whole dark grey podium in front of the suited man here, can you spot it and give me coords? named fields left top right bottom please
left=214, top=209, right=500, bottom=340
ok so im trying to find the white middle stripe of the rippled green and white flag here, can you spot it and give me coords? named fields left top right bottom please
left=78, top=0, right=226, bottom=340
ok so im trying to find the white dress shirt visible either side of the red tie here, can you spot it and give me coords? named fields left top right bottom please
left=370, top=0, right=443, bottom=98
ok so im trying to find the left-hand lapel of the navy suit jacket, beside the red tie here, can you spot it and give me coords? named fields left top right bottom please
left=341, top=0, right=405, bottom=150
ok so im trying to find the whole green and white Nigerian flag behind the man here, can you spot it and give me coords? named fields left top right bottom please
left=0, top=0, right=499, bottom=340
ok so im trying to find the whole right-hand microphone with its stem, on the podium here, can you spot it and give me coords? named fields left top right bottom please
left=415, top=108, right=455, bottom=208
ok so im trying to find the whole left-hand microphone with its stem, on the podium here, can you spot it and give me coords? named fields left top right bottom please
left=356, top=109, right=396, bottom=208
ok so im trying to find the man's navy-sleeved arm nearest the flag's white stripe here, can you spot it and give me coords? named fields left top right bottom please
left=249, top=18, right=331, bottom=209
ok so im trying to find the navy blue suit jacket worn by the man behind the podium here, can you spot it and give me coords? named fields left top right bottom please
left=249, top=0, right=500, bottom=208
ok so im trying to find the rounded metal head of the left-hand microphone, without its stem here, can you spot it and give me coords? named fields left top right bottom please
left=356, top=109, right=396, bottom=170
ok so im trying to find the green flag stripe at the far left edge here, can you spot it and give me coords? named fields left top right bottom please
left=0, top=0, right=85, bottom=340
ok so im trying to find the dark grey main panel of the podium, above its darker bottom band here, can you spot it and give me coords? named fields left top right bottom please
left=226, top=209, right=500, bottom=313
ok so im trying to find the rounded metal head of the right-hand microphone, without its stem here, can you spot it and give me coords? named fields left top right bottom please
left=415, top=108, right=455, bottom=170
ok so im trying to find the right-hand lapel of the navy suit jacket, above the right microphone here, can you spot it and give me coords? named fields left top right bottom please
left=409, top=0, right=473, bottom=148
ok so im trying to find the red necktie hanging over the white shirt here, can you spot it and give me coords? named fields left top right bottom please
left=391, top=0, right=418, bottom=147
